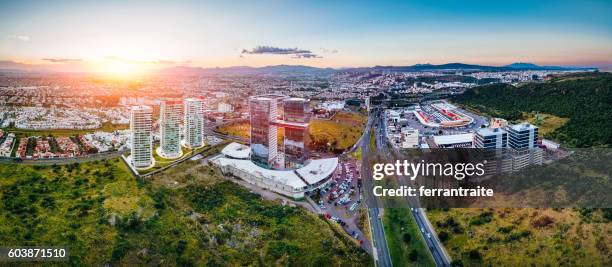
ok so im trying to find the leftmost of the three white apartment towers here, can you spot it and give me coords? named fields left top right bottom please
left=130, top=106, right=153, bottom=168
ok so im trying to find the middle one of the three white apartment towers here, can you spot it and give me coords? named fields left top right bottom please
left=157, top=101, right=183, bottom=158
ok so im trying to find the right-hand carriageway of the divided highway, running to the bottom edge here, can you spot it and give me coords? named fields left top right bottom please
left=375, top=110, right=451, bottom=266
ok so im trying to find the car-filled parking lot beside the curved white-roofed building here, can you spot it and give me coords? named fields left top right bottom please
left=310, top=159, right=370, bottom=248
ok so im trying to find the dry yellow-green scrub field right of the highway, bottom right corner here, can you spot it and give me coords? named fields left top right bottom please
left=428, top=209, right=612, bottom=266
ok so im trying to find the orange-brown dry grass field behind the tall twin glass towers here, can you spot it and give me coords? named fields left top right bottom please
left=217, top=112, right=367, bottom=152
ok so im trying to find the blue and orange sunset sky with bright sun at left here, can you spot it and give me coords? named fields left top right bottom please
left=0, top=0, right=612, bottom=72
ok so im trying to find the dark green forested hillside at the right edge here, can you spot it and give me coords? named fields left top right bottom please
left=454, top=73, right=612, bottom=147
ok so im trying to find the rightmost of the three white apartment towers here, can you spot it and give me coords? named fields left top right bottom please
left=183, top=98, right=204, bottom=149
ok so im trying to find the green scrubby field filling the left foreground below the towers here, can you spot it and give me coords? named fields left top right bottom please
left=0, top=159, right=372, bottom=266
